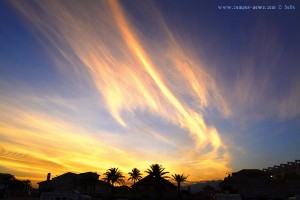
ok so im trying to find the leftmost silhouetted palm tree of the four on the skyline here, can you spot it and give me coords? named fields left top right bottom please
left=102, top=167, right=125, bottom=194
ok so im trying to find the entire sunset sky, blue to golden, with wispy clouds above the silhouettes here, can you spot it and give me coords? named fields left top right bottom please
left=0, top=0, right=300, bottom=188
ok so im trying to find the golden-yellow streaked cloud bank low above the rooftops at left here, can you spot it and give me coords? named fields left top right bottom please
left=0, top=98, right=144, bottom=186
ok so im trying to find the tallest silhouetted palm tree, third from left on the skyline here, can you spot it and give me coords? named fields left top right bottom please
left=145, top=164, right=170, bottom=199
